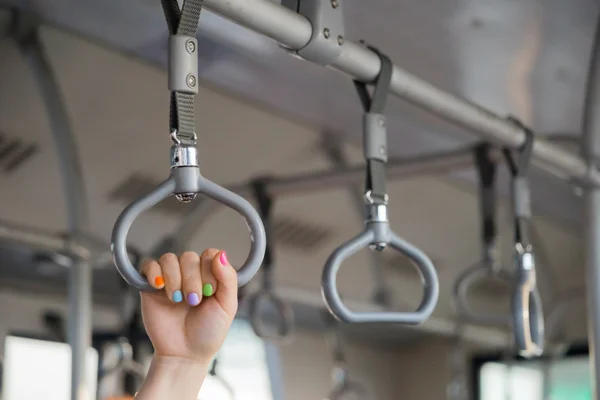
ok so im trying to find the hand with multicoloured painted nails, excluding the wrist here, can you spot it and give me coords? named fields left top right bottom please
left=141, top=249, right=238, bottom=366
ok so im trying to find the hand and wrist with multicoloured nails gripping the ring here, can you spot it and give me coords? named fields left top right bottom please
left=136, top=249, right=238, bottom=400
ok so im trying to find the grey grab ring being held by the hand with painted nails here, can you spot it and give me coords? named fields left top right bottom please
left=111, top=167, right=266, bottom=291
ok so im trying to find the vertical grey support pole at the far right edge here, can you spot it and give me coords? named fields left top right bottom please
left=582, top=12, right=600, bottom=400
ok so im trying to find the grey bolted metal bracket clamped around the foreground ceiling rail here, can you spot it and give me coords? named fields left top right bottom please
left=281, top=0, right=344, bottom=66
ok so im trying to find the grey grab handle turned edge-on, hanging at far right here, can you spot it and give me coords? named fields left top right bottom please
left=512, top=252, right=544, bottom=358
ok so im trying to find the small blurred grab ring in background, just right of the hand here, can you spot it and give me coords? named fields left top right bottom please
left=248, top=291, right=294, bottom=344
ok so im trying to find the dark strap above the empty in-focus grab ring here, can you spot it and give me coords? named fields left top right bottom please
left=353, top=46, right=394, bottom=204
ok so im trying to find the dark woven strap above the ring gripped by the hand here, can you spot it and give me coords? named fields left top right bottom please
left=161, top=0, right=204, bottom=144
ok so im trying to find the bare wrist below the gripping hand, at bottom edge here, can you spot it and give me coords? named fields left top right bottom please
left=136, top=355, right=210, bottom=400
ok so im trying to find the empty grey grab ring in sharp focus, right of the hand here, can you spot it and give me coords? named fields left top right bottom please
left=322, top=222, right=439, bottom=325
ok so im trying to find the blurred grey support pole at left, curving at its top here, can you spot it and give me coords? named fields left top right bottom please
left=15, top=18, right=92, bottom=400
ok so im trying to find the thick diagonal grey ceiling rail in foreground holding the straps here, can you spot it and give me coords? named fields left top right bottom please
left=204, top=0, right=600, bottom=186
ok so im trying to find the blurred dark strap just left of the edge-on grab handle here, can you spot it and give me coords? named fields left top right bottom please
left=474, top=143, right=496, bottom=244
